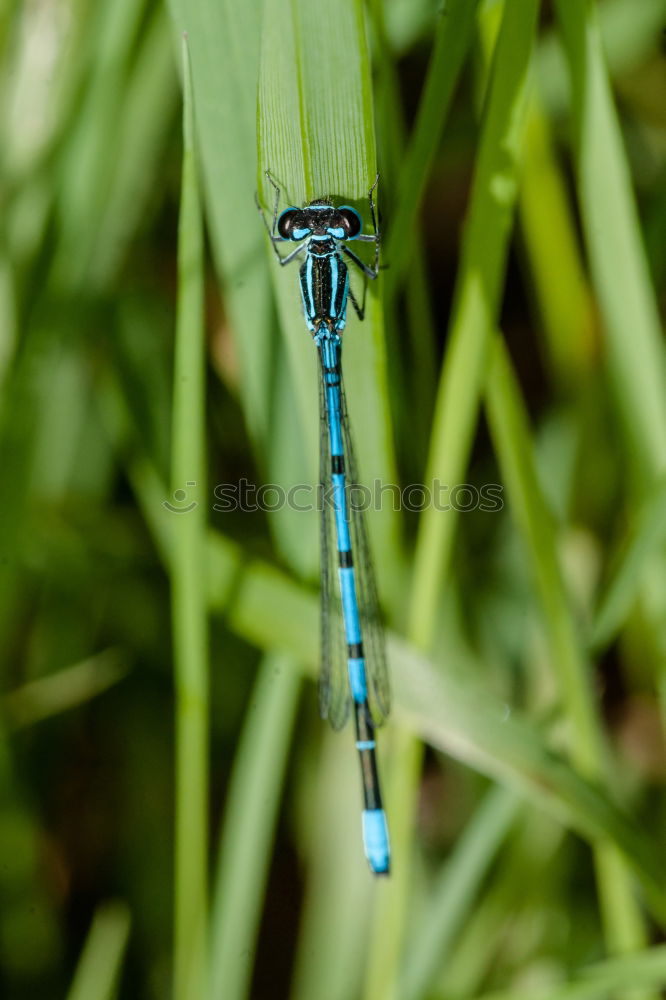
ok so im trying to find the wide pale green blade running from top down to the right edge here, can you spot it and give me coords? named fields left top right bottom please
left=555, top=0, right=666, bottom=488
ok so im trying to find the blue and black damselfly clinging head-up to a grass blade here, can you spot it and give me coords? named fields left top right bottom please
left=257, top=172, right=390, bottom=875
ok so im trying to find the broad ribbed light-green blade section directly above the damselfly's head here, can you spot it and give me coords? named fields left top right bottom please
left=258, top=0, right=377, bottom=205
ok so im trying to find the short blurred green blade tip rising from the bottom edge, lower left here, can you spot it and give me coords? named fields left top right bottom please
left=67, top=902, right=130, bottom=1000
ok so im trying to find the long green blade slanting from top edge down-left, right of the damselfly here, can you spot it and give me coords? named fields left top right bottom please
left=410, top=0, right=538, bottom=648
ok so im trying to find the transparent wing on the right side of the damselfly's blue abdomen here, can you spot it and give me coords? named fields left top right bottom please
left=340, top=372, right=391, bottom=726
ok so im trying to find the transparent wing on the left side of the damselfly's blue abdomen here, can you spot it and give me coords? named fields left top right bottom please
left=319, top=364, right=351, bottom=729
